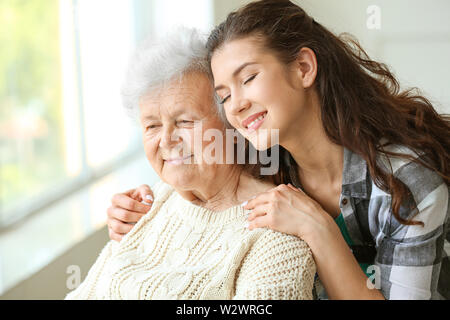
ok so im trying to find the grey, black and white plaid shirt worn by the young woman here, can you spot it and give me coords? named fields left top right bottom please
left=286, top=145, right=450, bottom=299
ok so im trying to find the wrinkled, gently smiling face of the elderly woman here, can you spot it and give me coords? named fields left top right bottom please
left=139, top=73, right=225, bottom=190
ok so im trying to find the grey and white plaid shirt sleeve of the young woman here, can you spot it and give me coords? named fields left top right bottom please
left=374, top=162, right=449, bottom=300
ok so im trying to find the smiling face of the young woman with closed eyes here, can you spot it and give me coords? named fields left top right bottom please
left=211, top=37, right=305, bottom=150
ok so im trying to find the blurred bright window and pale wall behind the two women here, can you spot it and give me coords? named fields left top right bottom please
left=0, top=0, right=450, bottom=299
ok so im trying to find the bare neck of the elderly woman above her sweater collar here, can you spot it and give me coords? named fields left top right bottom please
left=179, top=167, right=272, bottom=211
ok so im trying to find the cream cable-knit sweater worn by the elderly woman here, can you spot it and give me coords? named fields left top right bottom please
left=66, top=182, right=316, bottom=300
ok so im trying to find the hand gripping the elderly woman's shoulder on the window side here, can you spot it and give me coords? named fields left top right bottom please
left=107, top=184, right=153, bottom=241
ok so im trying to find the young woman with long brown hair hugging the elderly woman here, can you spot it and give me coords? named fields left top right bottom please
left=108, top=0, right=450, bottom=299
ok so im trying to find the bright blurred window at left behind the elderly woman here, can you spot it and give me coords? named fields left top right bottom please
left=0, top=0, right=139, bottom=230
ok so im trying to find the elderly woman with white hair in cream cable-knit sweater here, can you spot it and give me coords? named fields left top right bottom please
left=66, top=29, right=316, bottom=299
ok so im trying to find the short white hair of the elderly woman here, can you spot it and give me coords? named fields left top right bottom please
left=122, top=27, right=228, bottom=121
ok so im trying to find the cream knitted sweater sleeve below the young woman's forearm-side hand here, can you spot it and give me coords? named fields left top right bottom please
left=233, top=230, right=316, bottom=300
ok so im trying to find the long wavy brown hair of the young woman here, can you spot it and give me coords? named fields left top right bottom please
left=207, top=0, right=450, bottom=225
